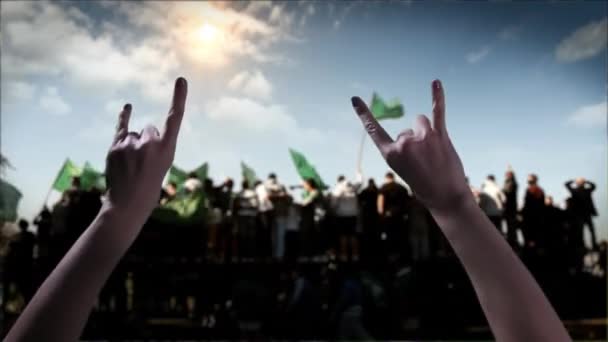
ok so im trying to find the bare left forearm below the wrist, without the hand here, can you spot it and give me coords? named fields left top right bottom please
left=6, top=204, right=143, bottom=341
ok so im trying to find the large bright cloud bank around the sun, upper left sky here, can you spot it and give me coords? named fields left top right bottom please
left=0, top=2, right=297, bottom=103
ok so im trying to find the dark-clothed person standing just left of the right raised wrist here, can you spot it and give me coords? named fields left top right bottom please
left=378, top=172, right=409, bottom=254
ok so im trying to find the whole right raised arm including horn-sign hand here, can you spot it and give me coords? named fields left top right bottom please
left=352, top=80, right=570, bottom=341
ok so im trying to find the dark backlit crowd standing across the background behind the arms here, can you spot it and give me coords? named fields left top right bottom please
left=3, top=167, right=607, bottom=339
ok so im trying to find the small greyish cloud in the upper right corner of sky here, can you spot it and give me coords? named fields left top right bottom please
left=555, top=17, right=608, bottom=62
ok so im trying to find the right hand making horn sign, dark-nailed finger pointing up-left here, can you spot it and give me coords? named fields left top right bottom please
left=352, top=80, right=473, bottom=210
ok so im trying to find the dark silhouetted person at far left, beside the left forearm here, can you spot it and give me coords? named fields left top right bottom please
left=5, top=219, right=36, bottom=302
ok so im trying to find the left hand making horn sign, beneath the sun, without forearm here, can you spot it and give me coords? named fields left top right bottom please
left=106, top=77, right=188, bottom=218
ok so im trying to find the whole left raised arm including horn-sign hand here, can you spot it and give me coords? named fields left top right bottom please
left=5, top=77, right=187, bottom=341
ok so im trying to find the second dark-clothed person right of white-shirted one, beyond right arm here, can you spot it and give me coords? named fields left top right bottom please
left=521, top=174, right=545, bottom=249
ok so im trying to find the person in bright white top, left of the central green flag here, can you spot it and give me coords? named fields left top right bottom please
left=254, top=180, right=275, bottom=258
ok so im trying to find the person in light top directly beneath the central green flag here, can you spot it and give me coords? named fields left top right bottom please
left=299, top=178, right=322, bottom=258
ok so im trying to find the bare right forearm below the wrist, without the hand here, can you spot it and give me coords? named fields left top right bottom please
left=431, top=198, right=570, bottom=341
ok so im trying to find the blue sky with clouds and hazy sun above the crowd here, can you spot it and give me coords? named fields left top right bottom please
left=0, top=1, right=608, bottom=238
